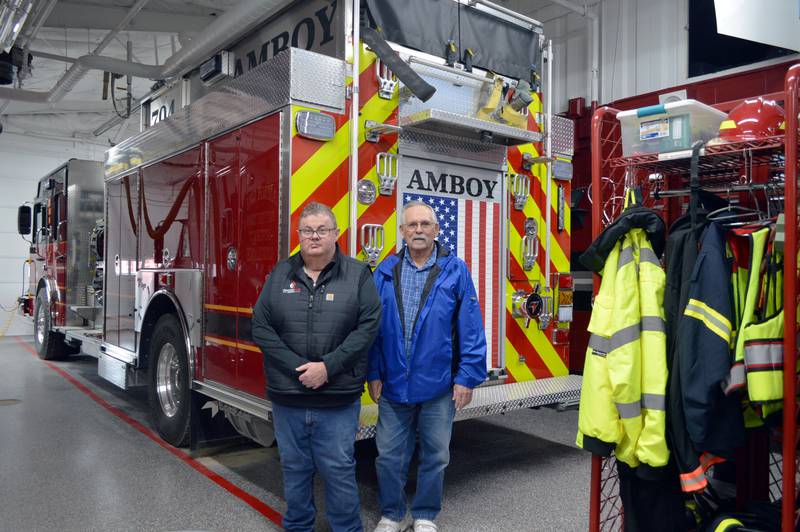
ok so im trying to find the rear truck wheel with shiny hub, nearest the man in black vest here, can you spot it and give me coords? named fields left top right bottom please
left=148, top=314, right=191, bottom=447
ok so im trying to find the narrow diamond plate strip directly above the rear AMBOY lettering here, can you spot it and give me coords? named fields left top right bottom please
left=398, top=129, right=506, bottom=169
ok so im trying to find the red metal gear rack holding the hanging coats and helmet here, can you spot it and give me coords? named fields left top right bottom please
left=589, top=64, right=800, bottom=532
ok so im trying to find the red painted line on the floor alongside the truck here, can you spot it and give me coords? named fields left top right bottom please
left=14, top=336, right=283, bottom=526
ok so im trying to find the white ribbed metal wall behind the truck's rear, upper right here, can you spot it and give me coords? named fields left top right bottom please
left=504, top=0, right=787, bottom=112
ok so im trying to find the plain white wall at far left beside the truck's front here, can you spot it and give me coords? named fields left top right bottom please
left=0, top=132, right=105, bottom=337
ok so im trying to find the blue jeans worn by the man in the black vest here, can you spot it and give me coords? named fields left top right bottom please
left=272, top=400, right=363, bottom=532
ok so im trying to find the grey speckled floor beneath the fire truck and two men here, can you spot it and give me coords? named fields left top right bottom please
left=0, top=337, right=590, bottom=532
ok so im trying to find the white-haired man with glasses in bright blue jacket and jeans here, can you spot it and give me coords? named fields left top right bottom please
left=367, top=201, right=486, bottom=532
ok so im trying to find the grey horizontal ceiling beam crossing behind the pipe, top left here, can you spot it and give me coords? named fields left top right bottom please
left=44, top=2, right=216, bottom=33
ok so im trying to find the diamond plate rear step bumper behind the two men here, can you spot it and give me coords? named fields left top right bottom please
left=356, top=375, right=582, bottom=440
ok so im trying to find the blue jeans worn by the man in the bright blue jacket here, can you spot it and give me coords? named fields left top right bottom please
left=375, top=392, right=456, bottom=521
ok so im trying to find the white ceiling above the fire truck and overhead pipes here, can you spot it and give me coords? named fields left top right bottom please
left=0, top=0, right=568, bottom=148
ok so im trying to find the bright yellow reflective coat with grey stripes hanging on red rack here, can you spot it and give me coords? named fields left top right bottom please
left=577, top=223, right=669, bottom=467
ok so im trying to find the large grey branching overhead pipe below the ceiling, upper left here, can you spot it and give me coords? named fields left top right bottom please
left=0, top=0, right=282, bottom=103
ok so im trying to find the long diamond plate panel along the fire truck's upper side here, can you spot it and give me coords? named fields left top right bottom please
left=106, top=48, right=345, bottom=179
